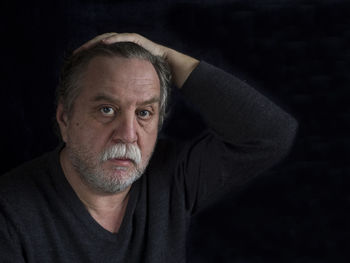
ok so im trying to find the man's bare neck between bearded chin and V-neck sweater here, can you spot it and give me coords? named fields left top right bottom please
left=60, top=148, right=130, bottom=233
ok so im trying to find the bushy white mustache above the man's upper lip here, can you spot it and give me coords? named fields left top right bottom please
left=101, top=143, right=141, bottom=164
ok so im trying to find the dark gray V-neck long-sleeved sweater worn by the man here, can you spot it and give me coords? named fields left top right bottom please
left=0, top=62, right=297, bottom=263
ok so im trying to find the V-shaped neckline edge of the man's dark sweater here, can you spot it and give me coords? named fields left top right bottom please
left=50, top=145, right=140, bottom=242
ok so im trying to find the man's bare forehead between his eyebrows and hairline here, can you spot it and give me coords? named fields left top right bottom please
left=80, top=56, right=160, bottom=102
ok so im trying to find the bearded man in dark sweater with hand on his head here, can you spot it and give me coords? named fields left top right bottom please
left=0, top=33, right=297, bottom=263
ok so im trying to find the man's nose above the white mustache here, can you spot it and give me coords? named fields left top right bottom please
left=113, top=114, right=137, bottom=143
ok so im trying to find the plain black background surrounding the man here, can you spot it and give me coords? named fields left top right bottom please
left=0, top=0, right=350, bottom=263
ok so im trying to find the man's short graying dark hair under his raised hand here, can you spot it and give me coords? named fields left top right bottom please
left=56, top=42, right=171, bottom=128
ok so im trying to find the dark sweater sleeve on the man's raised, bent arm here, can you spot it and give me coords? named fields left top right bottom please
left=178, top=62, right=298, bottom=213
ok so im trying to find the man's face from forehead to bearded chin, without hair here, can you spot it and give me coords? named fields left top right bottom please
left=59, top=56, right=160, bottom=193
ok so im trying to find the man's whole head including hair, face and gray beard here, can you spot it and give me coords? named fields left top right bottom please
left=57, top=42, right=170, bottom=193
